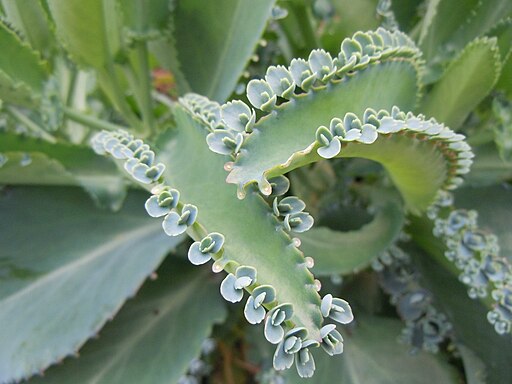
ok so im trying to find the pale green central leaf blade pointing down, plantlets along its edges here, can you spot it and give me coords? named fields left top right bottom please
left=160, top=107, right=322, bottom=338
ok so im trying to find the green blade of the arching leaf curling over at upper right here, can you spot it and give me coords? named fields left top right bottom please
left=227, top=57, right=432, bottom=212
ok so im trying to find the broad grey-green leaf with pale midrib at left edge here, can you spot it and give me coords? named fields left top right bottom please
left=0, top=187, right=180, bottom=382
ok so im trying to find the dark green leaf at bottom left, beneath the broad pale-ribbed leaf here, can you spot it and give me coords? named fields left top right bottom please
left=31, top=259, right=226, bottom=384
